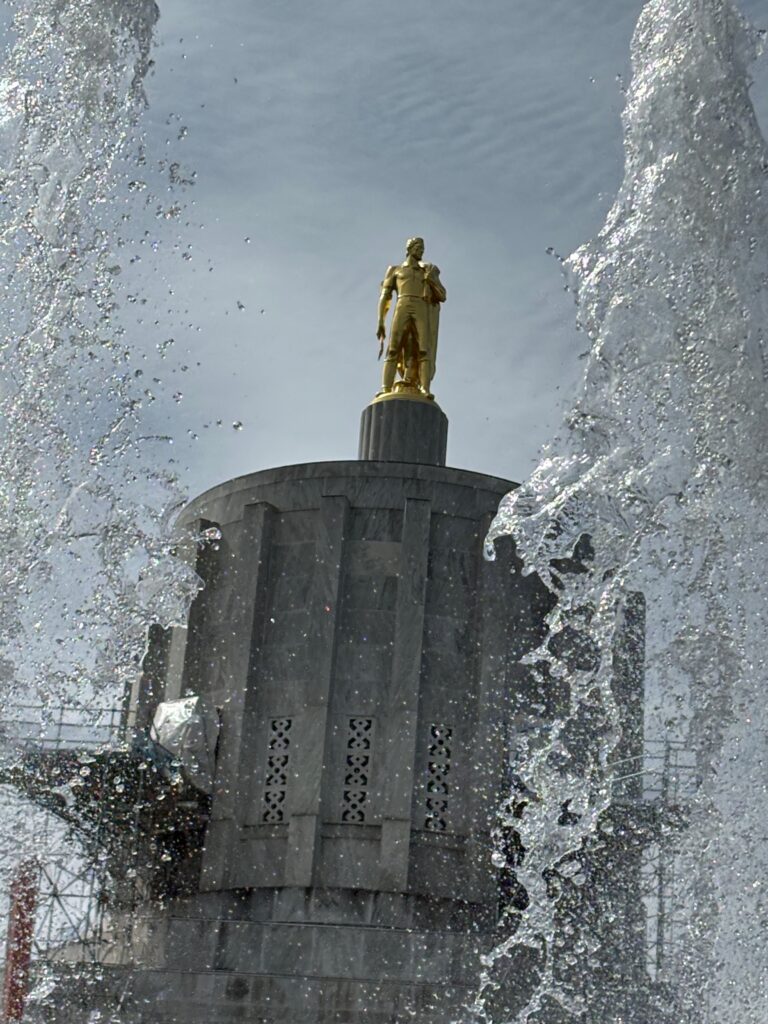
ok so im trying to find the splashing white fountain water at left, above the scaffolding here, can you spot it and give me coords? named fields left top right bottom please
left=0, top=0, right=201, bottom=705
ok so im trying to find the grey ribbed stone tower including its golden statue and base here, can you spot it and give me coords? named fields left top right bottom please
left=25, top=240, right=651, bottom=1024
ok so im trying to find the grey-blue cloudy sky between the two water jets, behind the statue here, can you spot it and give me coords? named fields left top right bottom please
left=118, top=0, right=768, bottom=495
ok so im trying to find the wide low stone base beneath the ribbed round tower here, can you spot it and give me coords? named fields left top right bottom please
left=30, top=894, right=499, bottom=1024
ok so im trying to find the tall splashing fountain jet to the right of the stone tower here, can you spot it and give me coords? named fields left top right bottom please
left=488, top=0, right=768, bottom=1024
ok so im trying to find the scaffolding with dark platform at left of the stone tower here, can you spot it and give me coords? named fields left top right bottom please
left=0, top=706, right=210, bottom=987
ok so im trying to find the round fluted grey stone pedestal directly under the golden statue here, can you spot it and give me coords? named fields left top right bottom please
left=357, top=394, right=447, bottom=466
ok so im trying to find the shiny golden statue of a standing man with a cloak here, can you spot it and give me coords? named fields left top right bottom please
left=376, top=239, right=445, bottom=398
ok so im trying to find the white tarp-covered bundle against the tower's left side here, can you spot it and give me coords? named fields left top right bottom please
left=150, top=696, right=219, bottom=793
